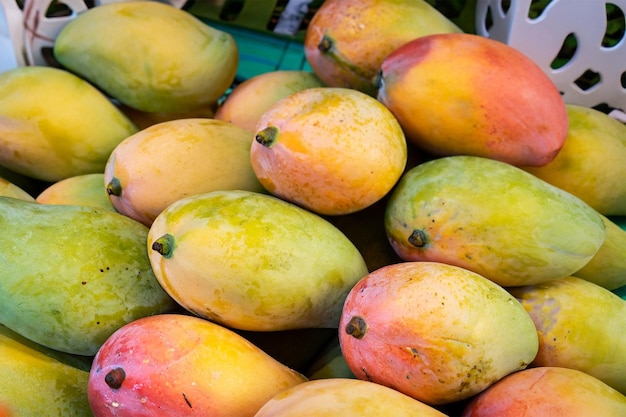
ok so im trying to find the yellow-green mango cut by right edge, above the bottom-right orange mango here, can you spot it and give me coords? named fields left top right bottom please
left=509, top=277, right=626, bottom=395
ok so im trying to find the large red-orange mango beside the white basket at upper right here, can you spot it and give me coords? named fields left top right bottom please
left=377, top=33, right=568, bottom=166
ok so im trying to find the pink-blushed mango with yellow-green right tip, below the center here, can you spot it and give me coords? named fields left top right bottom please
left=339, top=262, right=538, bottom=405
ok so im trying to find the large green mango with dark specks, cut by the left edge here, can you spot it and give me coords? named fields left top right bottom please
left=0, top=197, right=176, bottom=356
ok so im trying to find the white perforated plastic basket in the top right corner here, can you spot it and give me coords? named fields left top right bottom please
left=476, top=0, right=626, bottom=113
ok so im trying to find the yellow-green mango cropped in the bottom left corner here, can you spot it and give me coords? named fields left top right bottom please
left=0, top=325, right=93, bottom=417
